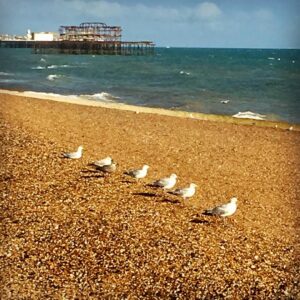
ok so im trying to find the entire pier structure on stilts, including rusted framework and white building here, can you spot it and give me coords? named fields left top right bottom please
left=0, top=23, right=155, bottom=55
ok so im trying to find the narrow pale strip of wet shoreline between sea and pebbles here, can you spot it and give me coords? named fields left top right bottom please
left=0, top=89, right=300, bottom=131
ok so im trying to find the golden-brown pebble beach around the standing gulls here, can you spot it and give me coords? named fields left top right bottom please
left=0, top=93, right=300, bottom=299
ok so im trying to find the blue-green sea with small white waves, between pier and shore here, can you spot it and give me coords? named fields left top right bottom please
left=0, top=47, right=300, bottom=124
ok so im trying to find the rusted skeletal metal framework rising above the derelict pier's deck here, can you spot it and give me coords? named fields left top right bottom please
left=59, top=22, right=122, bottom=42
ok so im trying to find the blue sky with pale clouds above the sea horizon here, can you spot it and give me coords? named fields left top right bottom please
left=0, top=0, right=300, bottom=49
